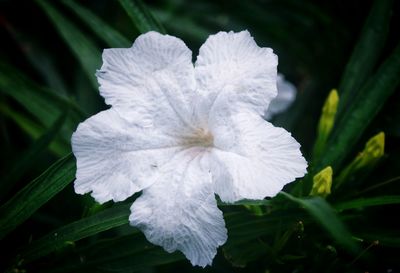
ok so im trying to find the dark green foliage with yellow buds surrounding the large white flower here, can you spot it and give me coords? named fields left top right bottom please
left=0, top=0, right=400, bottom=272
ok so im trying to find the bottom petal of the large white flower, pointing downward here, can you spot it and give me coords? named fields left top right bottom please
left=129, top=148, right=227, bottom=267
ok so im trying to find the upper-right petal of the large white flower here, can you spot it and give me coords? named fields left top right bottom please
left=195, top=31, right=278, bottom=114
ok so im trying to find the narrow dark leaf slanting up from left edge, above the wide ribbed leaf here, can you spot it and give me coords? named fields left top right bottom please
left=0, top=113, right=67, bottom=199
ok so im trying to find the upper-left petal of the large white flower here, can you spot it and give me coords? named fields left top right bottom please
left=97, top=31, right=195, bottom=127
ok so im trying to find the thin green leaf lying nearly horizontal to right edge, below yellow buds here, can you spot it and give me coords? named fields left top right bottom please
left=334, top=195, right=400, bottom=211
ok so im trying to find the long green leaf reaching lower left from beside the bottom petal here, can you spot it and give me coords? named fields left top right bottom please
left=21, top=202, right=131, bottom=262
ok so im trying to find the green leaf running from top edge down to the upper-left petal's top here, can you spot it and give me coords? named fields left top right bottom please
left=119, top=0, right=166, bottom=33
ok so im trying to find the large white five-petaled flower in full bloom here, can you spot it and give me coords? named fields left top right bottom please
left=72, top=31, right=307, bottom=267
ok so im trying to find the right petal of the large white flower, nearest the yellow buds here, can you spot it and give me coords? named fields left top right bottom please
left=211, top=111, right=307, bottom=202
